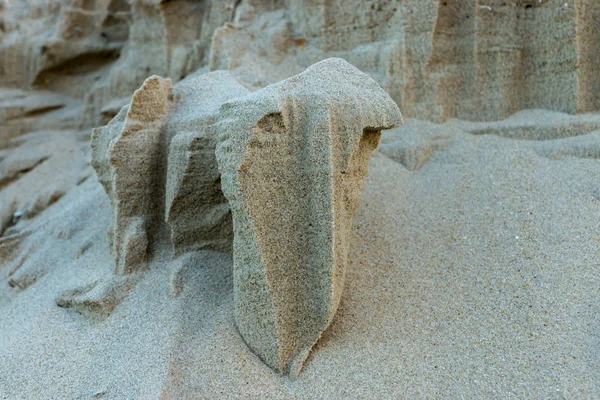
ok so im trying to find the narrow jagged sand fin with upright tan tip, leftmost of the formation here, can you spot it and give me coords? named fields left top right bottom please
left=92, top=76, right=172, bottom=274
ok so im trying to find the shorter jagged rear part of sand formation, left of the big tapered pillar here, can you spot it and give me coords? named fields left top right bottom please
left=58, top=71, right=247, bottom=316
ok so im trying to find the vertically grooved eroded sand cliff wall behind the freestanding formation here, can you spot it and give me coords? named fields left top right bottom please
left=0, top=0, right=600, bottom=126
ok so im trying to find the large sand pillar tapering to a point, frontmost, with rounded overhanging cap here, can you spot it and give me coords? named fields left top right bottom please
left=214, top=59, right=402, bottom=375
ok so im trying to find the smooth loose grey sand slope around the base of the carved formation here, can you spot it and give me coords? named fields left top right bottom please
left=0, top=111, right=600, bottom=399
